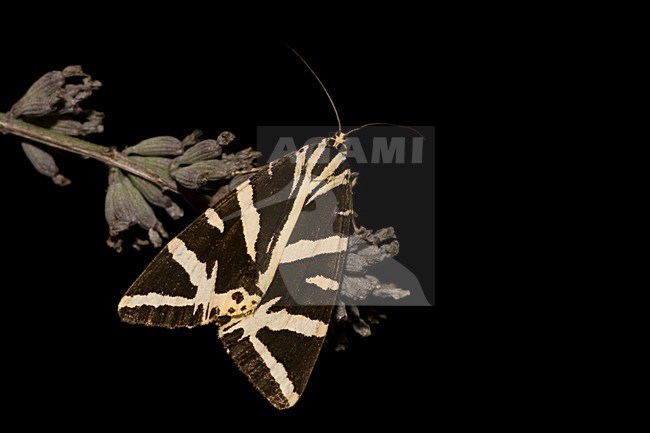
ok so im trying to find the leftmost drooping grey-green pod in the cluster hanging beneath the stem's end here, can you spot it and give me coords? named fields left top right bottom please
left=104, top=167, right=136, bottom=236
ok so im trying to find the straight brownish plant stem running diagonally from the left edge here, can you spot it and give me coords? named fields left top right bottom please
left=0, top=113, right=178, bottom=193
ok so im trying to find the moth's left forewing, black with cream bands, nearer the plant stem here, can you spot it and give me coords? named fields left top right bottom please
left=118, top=150, right=293, bottom=328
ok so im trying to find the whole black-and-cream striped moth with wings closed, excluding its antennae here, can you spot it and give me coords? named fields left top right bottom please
left=119, top=139, right=352, bottom=409
